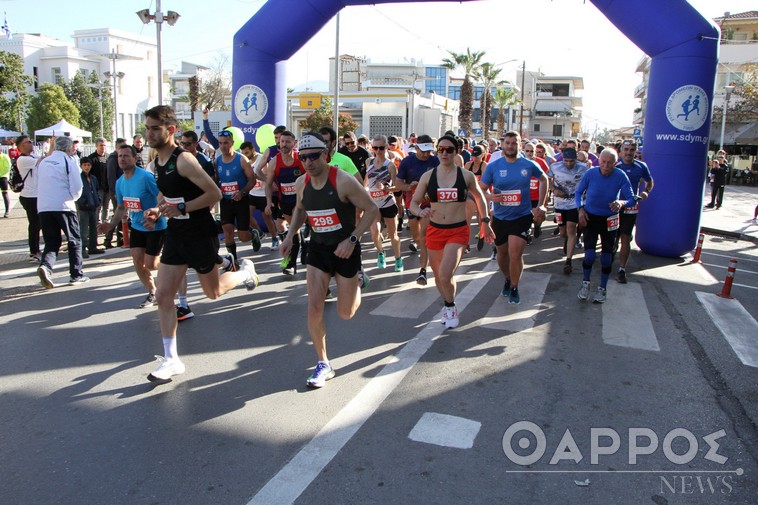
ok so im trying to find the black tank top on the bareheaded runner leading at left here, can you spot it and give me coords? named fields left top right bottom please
left=155, top=147, right=216, bottom=236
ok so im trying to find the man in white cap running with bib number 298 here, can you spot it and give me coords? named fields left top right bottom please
left=279, top=132, right=379, bottom=388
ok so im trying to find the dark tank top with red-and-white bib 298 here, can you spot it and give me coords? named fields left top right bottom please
left=303, top=166, right=355, bottom=246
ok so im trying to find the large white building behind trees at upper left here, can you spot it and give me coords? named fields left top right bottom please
left=0, top=28, right=162, bottom=138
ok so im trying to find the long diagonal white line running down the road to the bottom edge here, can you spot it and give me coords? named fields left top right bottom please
left=248, top=262, right=497, bottom=505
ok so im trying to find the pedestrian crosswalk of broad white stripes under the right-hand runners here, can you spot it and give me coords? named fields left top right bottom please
left=370, top=259, right=758, bottom=366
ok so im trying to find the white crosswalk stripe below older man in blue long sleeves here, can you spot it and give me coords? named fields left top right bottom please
left=604, top=282, right=661, bottom=351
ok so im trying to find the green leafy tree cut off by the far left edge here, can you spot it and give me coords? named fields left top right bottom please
left=0, top=51, right=33, bottom=131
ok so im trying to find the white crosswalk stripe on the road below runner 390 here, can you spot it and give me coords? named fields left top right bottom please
left=481, top=271, right=550, bottom=333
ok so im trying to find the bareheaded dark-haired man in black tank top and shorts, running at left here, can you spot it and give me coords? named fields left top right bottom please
left=144, top=105, right=258, bottom=382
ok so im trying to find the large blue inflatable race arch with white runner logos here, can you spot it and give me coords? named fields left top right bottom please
left=232, top=0, right=719, bottom=257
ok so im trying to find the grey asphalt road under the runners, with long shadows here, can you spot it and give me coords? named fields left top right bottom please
left=0, top=220, right=758, bottom=505
